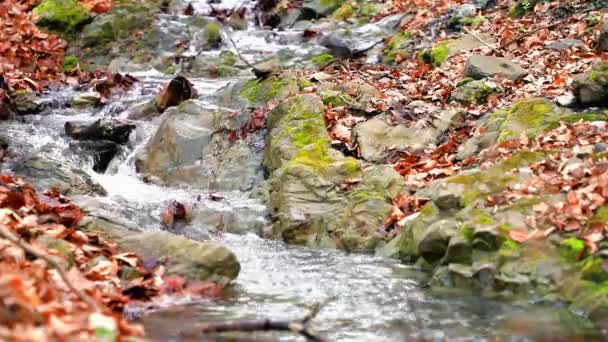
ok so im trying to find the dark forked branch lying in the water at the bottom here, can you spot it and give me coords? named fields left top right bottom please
left=182, top=301, right=328, bottom=342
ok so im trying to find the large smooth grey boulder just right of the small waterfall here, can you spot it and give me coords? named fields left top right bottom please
left=136, top=100, right=262, bottom=190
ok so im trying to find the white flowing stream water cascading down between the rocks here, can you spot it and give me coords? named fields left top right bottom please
left=1, top=1, right=604, bottom=341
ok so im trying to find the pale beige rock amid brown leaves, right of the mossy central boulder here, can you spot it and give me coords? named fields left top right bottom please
left=353, top=110, right=458, bottom=161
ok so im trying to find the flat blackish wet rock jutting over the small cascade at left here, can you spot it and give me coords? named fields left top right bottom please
left=64, top=119, right=135, bottom=144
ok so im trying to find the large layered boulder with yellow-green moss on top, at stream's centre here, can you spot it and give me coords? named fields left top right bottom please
left=264, top=94, right=403, bottom=252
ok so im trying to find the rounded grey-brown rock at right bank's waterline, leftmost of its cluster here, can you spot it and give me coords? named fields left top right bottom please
left=417, top=220, right=458, bottom=263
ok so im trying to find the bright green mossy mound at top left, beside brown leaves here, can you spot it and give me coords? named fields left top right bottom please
left=34, top=0, right=91, bottom=34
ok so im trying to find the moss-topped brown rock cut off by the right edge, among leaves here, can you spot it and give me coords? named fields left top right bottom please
left=572, top=62, right=608, bottom=106
